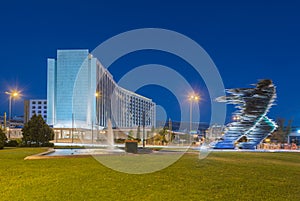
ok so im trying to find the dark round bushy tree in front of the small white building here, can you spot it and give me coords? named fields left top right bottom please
left=22, top=115, right=54, bottom=146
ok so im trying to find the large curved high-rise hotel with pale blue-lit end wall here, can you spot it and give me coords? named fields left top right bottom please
left=47, top=50, right=155, bottom=129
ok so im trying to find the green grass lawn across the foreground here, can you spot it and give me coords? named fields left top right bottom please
left=0, top=148, right=300, bottom=201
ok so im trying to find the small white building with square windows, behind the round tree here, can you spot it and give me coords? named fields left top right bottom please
left=24, top=99, right=47, bottom=123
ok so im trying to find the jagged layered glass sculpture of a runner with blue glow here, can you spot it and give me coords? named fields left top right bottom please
left=212, top=80, right=277, bottom=149
